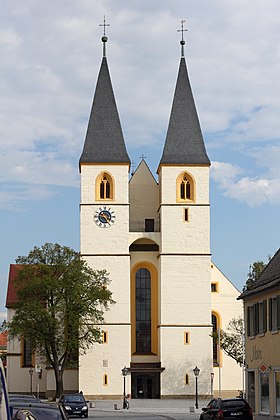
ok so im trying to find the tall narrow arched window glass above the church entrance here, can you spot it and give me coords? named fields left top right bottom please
left=135, top=268, right=151, bottom=353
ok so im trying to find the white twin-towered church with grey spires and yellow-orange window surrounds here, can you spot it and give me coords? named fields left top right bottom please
left=79, top=28, right=242, bottom=398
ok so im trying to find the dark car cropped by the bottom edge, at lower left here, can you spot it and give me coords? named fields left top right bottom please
left=10, top=400, right=68, bottom=420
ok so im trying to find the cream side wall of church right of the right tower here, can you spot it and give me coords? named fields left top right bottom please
left=211, top=263, right=243, bottom=396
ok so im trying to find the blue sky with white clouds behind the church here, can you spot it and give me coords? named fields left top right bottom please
left=0, top=0, right=280, bottom=318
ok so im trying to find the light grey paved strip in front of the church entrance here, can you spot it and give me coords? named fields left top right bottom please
left=88, top=399, right=202, bottom=417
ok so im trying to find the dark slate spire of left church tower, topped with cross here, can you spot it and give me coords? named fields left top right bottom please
left=79, top=17, right=130, bottom=169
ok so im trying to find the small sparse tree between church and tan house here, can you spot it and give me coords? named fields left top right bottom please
left=219, top=317, right=244, bottom=366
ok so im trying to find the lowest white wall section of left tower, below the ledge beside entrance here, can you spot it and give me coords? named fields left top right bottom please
left=79, top=325, right=131, bottom=398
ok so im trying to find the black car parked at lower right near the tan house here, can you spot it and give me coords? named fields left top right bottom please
left=199, top=398, right=253, bottom=420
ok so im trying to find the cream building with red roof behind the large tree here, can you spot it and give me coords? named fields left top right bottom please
left=6, top=264, right=78, bottom=397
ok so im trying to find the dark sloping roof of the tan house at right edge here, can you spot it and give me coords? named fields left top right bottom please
left=238, top=249, right=280, bottom=299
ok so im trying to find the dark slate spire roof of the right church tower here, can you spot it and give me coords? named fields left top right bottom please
left=160, top=57, right=210, bottom=165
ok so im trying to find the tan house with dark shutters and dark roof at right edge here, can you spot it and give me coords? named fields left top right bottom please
left=239, top=249, right=280, bottom=418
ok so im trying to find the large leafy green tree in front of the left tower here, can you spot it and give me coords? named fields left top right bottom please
left=8, top=243, right=114, bottom=397
